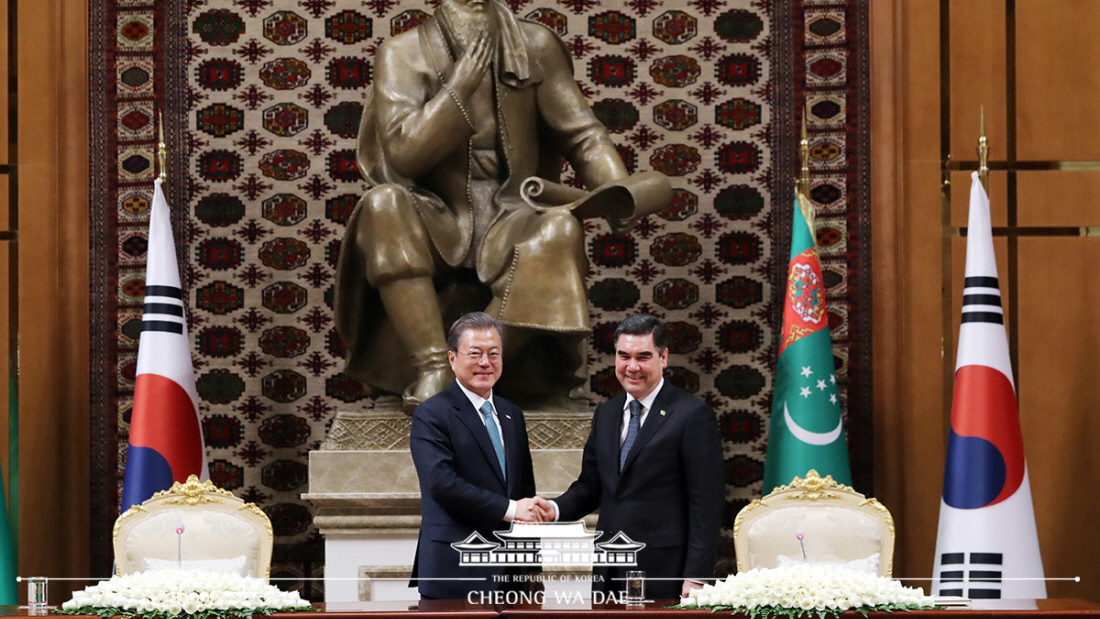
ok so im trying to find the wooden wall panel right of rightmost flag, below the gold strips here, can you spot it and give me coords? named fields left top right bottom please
left=1019, top=237, right=1100, bottom=597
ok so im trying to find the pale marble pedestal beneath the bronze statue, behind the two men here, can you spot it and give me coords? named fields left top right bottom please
left=303, top=409, right=594, bottom=603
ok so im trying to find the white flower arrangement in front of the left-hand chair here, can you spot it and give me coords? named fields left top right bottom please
left=56, top=570, right=312, bottom=619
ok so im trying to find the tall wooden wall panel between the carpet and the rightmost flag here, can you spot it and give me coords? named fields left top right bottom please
left=870, top=0, right=945, bottom=577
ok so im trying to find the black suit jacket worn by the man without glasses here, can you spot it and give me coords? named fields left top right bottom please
left=557, top=380, right=725, bottom=598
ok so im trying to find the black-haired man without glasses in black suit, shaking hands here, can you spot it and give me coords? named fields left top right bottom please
left=538, top=314, right=725, bottom=598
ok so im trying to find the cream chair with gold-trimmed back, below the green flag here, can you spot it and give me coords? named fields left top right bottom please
left=734, top=469, right=894, bottom=576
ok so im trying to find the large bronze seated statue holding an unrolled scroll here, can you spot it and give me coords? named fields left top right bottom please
left=336, top=0, right=671, bottom=411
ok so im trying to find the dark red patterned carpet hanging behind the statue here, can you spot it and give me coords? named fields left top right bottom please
left=91, top=0, right=871, bottom=598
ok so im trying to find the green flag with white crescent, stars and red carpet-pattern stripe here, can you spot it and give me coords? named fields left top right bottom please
left=761, top=196, right=851, bottom=495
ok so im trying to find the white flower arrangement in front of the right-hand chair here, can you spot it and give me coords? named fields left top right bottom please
left=677, top=564, right=934, bottom=618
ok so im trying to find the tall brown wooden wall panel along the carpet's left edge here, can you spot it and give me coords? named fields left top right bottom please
left=15, top=0, right=89, bottom=599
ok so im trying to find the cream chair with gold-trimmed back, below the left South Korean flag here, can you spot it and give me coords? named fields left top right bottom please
left=113, top=475, right=273, bottom=581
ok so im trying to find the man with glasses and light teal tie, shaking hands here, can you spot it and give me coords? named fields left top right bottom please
left=410, top=312, right=541, bottom=599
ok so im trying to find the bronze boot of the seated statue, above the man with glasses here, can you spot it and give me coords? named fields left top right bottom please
left=378, top=277, right=454, bottom=414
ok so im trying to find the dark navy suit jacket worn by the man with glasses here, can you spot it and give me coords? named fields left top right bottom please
left=409, top=383, right=535, bottom=598
